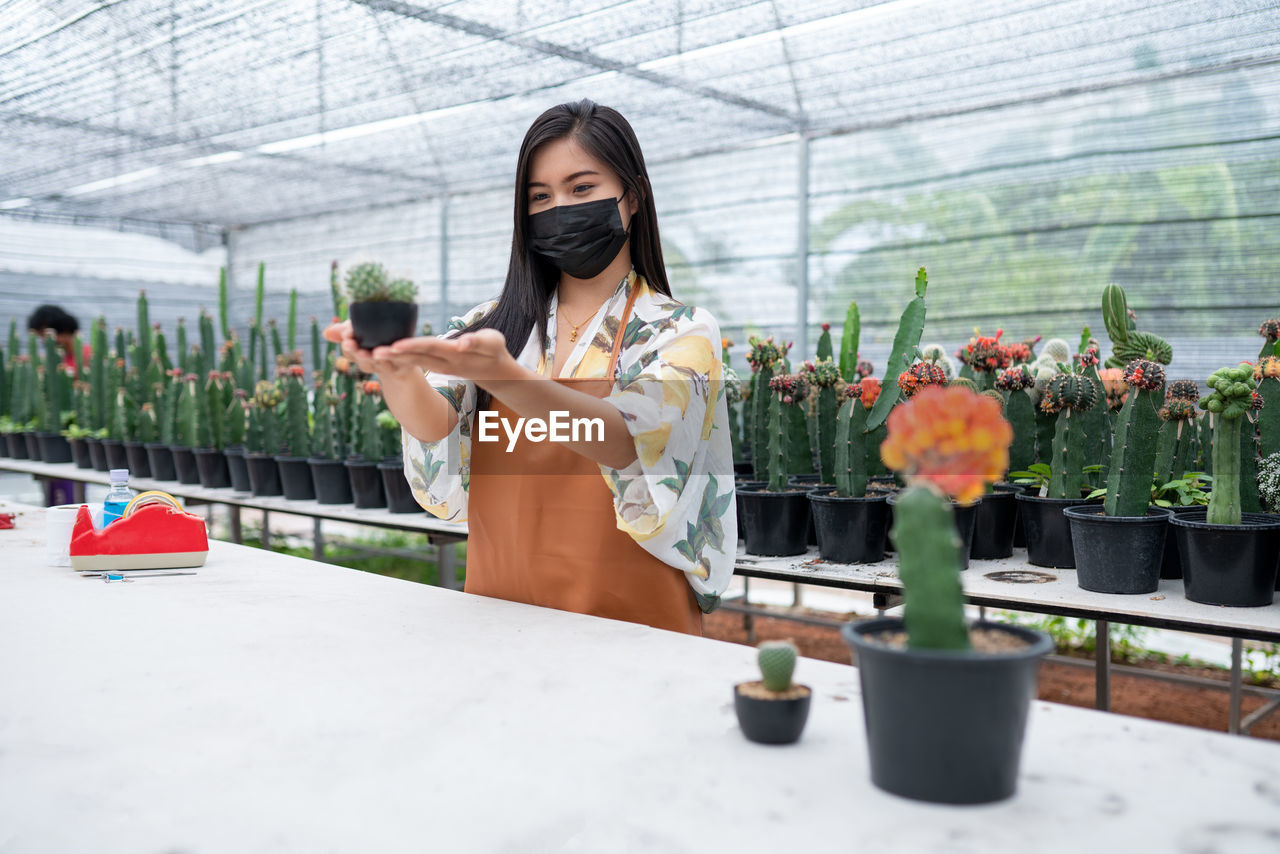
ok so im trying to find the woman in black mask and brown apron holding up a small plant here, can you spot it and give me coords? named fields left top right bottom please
left=326, top=100, right=737, bottom=634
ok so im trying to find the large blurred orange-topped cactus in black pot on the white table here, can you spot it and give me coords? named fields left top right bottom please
left=842, top=387, right=1052, bottom=804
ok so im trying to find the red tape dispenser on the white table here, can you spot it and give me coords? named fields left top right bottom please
left=70, top=493, right=209, bottom=572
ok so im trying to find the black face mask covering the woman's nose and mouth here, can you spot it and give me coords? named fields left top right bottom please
left=529, top=198, right=630, bottom=279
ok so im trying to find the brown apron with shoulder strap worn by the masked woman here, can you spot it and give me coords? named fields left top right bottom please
left=465, top=286, right=703, bottom=635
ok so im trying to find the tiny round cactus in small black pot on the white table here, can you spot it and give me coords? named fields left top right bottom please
left=733, top=640, right=813, bottom=744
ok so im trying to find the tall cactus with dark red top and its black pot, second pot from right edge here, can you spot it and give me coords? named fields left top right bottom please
left=1062, top=359, right=1170, bottom=594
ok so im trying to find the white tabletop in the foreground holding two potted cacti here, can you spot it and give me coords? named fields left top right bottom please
left=0, top=508, right=1280, bottom=854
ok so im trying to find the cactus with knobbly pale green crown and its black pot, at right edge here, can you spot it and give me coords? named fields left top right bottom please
left=1171, top=364, right=1280, bottom=606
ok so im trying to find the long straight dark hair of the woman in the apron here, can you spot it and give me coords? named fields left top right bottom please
left=463, top=99, right=671, bottom=408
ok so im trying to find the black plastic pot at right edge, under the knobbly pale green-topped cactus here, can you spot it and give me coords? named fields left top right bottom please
left=1169, top=510, right=1280, bottom=607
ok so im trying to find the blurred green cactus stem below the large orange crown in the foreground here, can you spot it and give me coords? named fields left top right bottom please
left=893, top=487, right=969, bottom=649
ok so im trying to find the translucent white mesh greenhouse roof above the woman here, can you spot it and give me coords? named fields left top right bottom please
left=0, top=0, right=1276, bottom=227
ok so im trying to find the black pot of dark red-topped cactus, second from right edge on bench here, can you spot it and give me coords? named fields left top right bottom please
left=1062, top=504, right=1170, bottom=594
